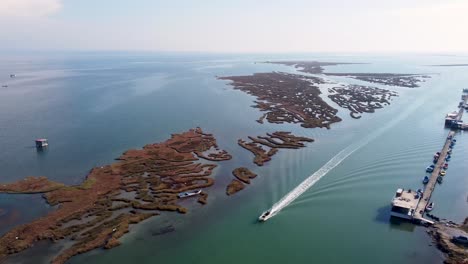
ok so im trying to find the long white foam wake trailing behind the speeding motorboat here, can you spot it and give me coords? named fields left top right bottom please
left=264, top=93, right=425, bottom=220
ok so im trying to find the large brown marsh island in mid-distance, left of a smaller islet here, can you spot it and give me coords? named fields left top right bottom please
left=219, top=72, right=341, bottom=128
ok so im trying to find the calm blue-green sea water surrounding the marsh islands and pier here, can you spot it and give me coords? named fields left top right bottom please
left=0, top=53, right=468, bottom=264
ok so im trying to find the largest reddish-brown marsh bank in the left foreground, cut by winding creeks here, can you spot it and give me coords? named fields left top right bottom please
left=0, top=128, right=231, bottom=264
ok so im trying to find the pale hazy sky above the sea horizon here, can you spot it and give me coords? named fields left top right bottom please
left=0, top=0, right=468, bottom=52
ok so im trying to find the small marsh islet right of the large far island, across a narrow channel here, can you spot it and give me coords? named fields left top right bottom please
left=328, top=85, right=398, bottom=119
